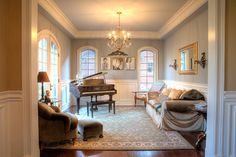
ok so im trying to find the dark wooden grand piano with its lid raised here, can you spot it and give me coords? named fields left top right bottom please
left=70, top=72, right=117, bottom=114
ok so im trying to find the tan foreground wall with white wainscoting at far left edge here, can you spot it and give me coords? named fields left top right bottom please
left=0, top=0, right=24, bottom=157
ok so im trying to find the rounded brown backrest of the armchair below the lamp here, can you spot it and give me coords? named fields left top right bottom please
left=38, top=102, right=55, bottom=119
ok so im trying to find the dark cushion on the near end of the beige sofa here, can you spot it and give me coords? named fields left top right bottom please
left=180, top=89, right=205, bottom=100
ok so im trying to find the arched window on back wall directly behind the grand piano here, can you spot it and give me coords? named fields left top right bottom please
left=77, top=47, right=97, bottom=77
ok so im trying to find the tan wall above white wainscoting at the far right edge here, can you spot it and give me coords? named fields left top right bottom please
left=225, top=0, right=236, bottom=91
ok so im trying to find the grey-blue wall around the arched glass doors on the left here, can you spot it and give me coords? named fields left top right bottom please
left=38, top=12, right=71, bottom=80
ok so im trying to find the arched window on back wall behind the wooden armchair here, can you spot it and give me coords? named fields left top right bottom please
left=138, top=48, right=158, bottom=91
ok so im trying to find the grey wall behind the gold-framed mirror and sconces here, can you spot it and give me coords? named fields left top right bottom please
left=164, top=5, right=208, bottom=84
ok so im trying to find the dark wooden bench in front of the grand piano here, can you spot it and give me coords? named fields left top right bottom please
left=87, top=100, right=116, bottom=118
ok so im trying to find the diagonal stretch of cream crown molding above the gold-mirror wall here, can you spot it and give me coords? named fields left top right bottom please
left=159, top=0, right=207, bottom=38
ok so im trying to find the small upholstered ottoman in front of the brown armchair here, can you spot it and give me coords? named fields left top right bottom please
left=78, top=119, right=103, bottom=141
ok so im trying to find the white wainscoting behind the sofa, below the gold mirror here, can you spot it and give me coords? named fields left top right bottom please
left=164, top=80, right=208, bottom=99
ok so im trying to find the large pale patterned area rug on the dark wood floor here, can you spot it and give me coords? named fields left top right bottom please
left=48, top=106, right=194, bottom=150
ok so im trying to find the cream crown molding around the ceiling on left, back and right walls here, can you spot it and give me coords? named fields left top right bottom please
left=38, top=0, right=207, bottom=39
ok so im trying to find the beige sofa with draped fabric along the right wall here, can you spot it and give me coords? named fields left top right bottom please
left=146, top=89, right=206, bottom=131
